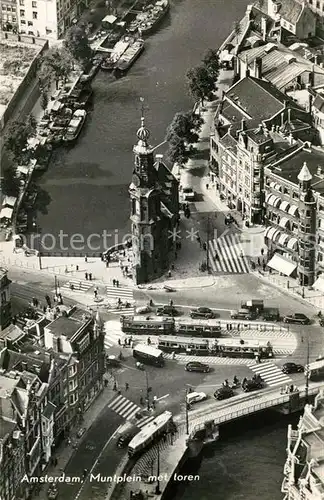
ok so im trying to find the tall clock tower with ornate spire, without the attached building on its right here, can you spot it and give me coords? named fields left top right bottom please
left=129, top=116, right=163, bottom=284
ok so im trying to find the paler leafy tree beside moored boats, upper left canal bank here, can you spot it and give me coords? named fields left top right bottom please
left=38, top=47, right=74, bottom=93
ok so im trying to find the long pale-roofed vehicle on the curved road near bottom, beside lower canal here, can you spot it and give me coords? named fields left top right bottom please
left=128, top=411, right=172, bottom=457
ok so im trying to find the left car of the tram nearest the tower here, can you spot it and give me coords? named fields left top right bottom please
left=120, top=316, right=174, bottom=335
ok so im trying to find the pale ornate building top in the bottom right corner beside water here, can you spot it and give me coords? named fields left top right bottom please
left=281, top=392, right=324, bottom=500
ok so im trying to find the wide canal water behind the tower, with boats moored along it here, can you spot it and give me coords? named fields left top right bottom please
left=37, top=0, right=245, bottom=251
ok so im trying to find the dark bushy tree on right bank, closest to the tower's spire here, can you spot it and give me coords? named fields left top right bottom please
left=166, top=112, right=203, bottom=144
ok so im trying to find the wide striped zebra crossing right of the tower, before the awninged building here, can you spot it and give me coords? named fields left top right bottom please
left=208, top=234, right=250, bottom=274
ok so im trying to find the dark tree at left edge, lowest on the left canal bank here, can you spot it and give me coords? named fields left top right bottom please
left=4, top=115, right=37, bottom=160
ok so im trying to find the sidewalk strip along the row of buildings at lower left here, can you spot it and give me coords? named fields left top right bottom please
left=37, top=387, right=116, bottom=500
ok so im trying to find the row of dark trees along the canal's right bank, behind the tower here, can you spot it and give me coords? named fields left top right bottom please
left=165, top=49, right=220, bottom=165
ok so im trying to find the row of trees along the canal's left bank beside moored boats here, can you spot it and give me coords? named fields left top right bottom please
left=1, top=26, right=92, bottom=196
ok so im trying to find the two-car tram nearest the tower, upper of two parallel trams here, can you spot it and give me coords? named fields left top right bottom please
left=120, top=316, right=221, bottom=338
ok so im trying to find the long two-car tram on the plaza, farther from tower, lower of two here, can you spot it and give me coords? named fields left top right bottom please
left=158, top=336, right=273, bottom=359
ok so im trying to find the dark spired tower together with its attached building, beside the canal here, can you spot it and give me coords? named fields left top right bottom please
left=129, top=114, right=179, bottom=284
